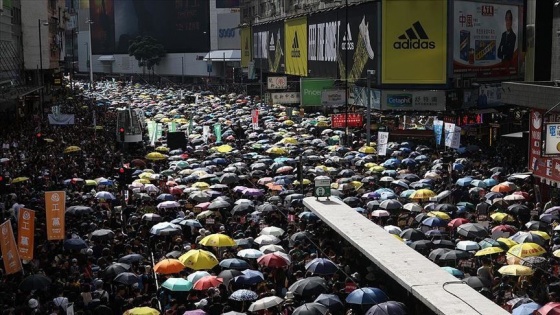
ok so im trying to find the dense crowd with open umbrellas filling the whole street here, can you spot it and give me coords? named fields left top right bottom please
left=0, top=83, right=560, bottom=315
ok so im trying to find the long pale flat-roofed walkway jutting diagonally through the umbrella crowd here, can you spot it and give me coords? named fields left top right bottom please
left=303, top=197, right=509, bottom=315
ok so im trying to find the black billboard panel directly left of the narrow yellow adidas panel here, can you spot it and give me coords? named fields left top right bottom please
left=253, top=21, right=284, bottom=73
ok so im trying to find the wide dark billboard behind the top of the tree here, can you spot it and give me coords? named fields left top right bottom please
left=90, top=0, right=210, bottom=55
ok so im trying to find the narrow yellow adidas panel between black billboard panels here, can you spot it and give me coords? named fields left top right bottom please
left=284, top=17, right=307, bottom=77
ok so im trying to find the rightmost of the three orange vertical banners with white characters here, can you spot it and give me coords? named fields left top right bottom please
left=45, top=191, right=66, bottom=241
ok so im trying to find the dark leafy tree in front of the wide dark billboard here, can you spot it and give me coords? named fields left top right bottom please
left=128, top=36, right=166, bottom=74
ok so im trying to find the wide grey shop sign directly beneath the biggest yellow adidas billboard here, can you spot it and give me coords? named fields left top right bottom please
left=381, top=90, right=445, bottom=111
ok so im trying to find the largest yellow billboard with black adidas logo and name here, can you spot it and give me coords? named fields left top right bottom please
left=381, top=0, right=447, bottom=84
